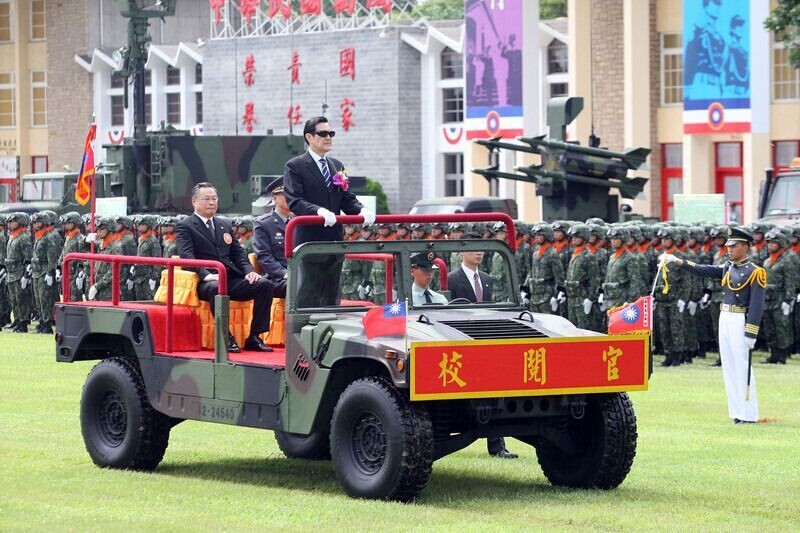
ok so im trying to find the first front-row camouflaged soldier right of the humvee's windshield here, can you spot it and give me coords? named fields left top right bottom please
left=523, top=222, right=565, bottom=314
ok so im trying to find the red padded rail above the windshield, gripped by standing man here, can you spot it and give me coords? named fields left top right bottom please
left=284, top=213, right=517, bottom=258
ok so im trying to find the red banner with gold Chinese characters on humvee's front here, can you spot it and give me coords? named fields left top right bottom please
left=411, top=333, right=650, bottom=400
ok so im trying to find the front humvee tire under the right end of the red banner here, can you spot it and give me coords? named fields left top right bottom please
left=536, top=392, right=637, bottom=490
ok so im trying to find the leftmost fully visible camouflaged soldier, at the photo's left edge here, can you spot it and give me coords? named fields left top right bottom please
left=6, top=213, right=33, bottom=333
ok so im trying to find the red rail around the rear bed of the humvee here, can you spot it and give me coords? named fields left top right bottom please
left=61, top=253, right=228, bottom=352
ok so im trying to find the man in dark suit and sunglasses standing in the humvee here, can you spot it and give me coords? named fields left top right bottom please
left=283, top=117, right=375, bottom=308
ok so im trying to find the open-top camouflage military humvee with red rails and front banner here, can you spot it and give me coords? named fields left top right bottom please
left=56, top=213, right=651, bottom=501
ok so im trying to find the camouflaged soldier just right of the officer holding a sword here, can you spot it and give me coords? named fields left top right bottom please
left=762, top=229, right=798, bottom=365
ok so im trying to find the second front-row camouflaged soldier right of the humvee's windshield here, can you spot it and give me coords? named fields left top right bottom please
left=565, top=224, right=601, bottom=329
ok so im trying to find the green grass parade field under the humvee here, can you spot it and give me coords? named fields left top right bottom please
left=0, top=332, right=800, bottom=532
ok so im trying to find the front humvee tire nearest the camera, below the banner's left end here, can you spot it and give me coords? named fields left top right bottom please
left=331, top=377, right=433, bottom=502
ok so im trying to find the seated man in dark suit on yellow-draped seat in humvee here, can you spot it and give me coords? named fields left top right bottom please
left=175, top=182, right=286, bottom=352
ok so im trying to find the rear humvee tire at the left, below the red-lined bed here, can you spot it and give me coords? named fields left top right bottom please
left=81, top=357, right=172, bottom=470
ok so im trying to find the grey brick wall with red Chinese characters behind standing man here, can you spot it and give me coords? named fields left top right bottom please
left=203, top=27, right=422, bottom=212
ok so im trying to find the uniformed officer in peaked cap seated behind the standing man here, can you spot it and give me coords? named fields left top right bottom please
left=253, top=178, right=292, bottom=280
